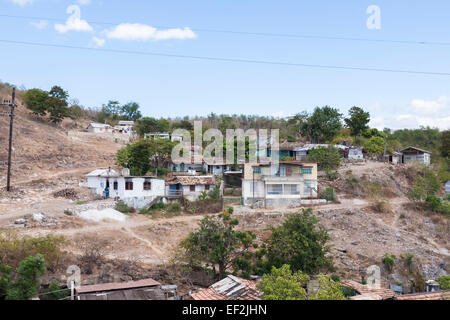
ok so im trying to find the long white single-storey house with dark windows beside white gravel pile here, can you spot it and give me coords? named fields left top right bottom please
left=83, top=169, right=165, bottom=209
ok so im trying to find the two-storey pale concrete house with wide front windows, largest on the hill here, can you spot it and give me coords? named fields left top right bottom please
left=242, top=161, right=317, bottom=207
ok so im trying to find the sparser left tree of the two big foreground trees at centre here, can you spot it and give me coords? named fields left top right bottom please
left=180, top=213, right=255, bottom=279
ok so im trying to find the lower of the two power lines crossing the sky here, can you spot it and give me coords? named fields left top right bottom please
left=0, top=39, right=450, bottom=76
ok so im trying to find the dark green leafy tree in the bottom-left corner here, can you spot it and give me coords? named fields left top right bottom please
left=6, top=254, right=47, bottom=300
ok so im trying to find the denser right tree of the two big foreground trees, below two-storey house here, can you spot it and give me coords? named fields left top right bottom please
left=264, top=208, right=332, bottom=274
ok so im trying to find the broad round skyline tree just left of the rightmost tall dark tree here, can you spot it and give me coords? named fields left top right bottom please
left=303, top=106, right=342, bottom=142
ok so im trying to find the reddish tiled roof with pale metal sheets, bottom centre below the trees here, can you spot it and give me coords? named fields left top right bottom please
left=191, top=275, right=262, bottom=300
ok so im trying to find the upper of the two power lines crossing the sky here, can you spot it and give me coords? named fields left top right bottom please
left=0, top=14, right=450, bottom=46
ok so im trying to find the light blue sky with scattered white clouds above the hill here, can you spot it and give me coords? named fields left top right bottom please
left=0, top=0, right=450, bottom=130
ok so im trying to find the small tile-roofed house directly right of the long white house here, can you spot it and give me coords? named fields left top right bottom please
left=166, top=176, right=216, bottom=201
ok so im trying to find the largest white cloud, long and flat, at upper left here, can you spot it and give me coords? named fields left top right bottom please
left=104, top=23, right=197, bottom=41
